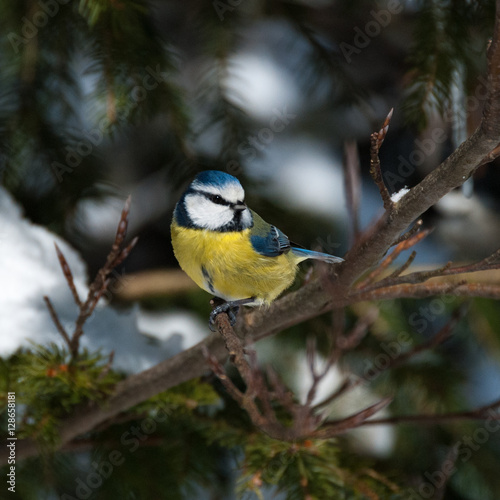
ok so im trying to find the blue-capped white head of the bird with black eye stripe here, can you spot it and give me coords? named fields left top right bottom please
left=175, top=170, right=253, bottom=232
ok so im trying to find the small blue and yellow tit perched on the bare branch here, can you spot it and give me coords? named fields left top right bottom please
left=171, top=170, right=343, bottom=330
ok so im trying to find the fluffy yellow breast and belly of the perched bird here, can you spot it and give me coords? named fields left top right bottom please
left=171, top=222, right=300, bottom=303
